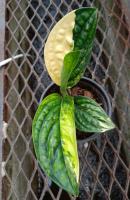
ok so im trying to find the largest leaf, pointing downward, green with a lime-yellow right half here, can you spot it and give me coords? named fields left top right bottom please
left=32, top=93, right=78, bottom=196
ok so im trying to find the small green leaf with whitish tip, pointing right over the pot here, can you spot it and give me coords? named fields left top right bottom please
left=74, top=96, right=115, bottom=133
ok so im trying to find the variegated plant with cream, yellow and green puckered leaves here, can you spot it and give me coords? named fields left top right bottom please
left=32, top=8, right=114, bottom=196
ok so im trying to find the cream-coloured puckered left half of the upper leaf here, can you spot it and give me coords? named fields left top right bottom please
left=44, top=11, right=75, bottom=85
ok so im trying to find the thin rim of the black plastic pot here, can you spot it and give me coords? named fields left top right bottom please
left=40, top=77, right=112, bottom=144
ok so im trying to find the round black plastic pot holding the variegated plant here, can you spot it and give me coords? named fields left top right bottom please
left=41, top=77, right=111, bottom=143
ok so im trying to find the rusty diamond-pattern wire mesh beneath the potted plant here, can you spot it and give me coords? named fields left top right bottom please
left=2, top=0, right=130, bottom=200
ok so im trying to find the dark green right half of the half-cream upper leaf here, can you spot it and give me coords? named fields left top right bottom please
left=68, top=8, right=97, bottom=87
